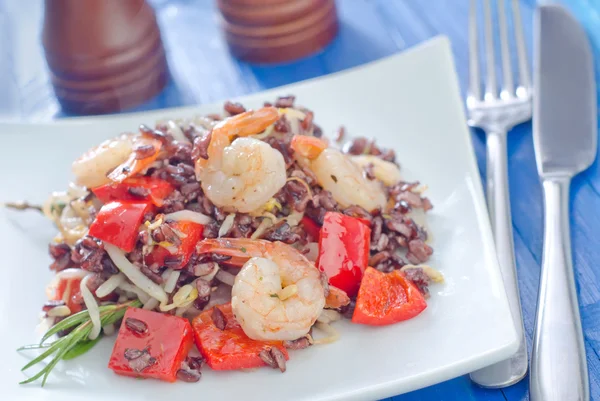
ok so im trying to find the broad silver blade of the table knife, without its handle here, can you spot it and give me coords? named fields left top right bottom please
left=533, top=5, right=598, bottom=176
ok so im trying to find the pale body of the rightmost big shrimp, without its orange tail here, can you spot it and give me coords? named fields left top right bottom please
left=308, top=148, right=387, bottom=211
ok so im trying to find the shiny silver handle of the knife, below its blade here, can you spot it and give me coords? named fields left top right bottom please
left=530, top=176, right=590, bottom=401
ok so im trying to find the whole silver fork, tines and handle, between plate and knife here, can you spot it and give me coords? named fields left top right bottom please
left=466, top=0, right=532, bottom=388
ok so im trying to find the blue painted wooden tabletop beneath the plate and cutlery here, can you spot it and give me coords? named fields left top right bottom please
left=0, top=0, right=600, bottom=401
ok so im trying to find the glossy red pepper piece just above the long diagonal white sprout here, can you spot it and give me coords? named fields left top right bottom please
left=89, top=201, right=152, bottom=252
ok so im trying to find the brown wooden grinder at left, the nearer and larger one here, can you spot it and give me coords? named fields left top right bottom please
left=42, top=0, right=168, bottom=114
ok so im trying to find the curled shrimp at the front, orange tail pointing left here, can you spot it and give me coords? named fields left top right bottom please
left=197, top=238, right=325, bottom=340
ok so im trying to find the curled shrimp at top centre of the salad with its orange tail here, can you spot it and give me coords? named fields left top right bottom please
left=196, top=107, right=286, bottom=213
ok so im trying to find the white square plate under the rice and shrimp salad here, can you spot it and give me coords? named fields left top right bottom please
left=0, top=38, right=517, bottom=401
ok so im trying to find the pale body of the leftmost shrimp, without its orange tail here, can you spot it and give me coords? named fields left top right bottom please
left=71, top=134, right=133, bottom=188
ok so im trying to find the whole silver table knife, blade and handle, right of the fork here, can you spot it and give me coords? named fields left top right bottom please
left=530, top=5, right=598, bottom=401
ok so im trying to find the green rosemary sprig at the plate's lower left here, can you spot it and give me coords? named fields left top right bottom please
left=17, top=300, right=142, bottom=387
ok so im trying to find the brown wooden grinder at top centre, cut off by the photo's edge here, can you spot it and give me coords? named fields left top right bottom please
left=217, top=0, right=338, bottom=64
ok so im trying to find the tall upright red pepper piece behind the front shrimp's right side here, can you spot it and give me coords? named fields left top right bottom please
left=317, top=212, right=371, bottom=297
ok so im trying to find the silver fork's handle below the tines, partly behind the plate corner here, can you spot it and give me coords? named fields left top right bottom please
left=470, top=131, right=527, bottom=388
